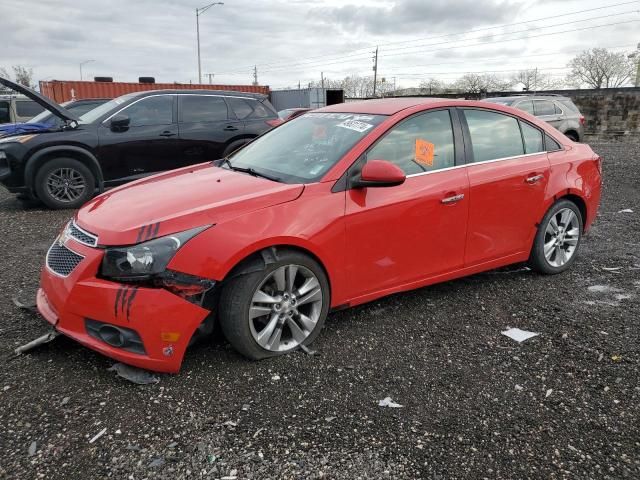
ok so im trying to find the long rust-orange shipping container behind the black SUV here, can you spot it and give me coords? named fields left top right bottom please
left=40, top=80, right=269, bottom=103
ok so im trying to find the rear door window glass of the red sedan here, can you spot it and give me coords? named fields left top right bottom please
left=464, top=109, right=524, bottom=162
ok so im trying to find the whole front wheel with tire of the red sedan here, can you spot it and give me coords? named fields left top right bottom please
left=219, top=250, right=330, bottom=360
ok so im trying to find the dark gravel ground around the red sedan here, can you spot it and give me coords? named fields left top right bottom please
left=0, top=143, right=640, bottom=479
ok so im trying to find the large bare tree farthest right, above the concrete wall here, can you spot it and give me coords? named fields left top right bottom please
left=567, top=48, right=634, bottom=88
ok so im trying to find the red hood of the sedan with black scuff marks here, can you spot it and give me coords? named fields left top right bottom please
left=76, top=164, right=304, bottom=245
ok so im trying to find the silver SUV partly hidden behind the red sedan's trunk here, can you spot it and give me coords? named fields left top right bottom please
left=484, top=95, right=584, bottom=142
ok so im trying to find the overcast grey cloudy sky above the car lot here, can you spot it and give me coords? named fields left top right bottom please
left=0, top=0, right=640, bottom=88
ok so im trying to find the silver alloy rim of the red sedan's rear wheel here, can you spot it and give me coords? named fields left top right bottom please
left=544, top=208, right=580, bottom=267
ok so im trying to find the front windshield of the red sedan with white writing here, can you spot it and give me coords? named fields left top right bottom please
left=223, top=113, right=386, bottom=183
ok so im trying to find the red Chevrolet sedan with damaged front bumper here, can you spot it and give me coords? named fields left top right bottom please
left=37, top=98, right=601, bottom=372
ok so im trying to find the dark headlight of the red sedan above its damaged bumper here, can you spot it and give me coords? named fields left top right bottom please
left=101, top=225, right=210, bottom=281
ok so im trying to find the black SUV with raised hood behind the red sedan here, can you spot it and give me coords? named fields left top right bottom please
left=0, top=77, right=282, bottom=208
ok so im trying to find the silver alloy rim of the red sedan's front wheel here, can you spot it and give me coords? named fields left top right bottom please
left=249, top=265, right=323, bottom=352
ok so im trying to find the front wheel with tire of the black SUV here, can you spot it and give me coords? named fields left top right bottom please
left=34, top=157, right=96, bottom=210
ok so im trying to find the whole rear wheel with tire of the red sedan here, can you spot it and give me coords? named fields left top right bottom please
left=529, top=200, right=583, bottom=275
